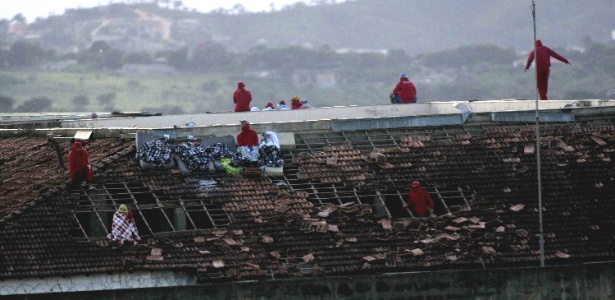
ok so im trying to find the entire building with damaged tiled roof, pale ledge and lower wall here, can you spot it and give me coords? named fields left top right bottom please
left=0, top=100, right=615, bottom=299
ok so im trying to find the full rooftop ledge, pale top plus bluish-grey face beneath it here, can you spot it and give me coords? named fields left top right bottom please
left=0, top=99, right=615, bottom=136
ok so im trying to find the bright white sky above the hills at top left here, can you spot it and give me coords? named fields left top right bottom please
left=0, top=0, right=328, bottom=23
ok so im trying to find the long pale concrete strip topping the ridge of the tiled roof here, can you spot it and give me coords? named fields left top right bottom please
left=62, top=100, right=615, bottom=128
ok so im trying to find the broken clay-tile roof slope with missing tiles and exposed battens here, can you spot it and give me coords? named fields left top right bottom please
left=0, top=100, right=615, bottom=282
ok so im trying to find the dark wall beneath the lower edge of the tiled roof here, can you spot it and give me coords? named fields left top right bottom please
left=6, top=262, right=615, bottom=300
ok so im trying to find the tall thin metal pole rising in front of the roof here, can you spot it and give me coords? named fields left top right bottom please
left=532, top=0, right=545, bottom=267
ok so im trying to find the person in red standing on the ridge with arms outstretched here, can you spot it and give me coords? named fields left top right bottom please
left=525, top=40, right=570, bottom=100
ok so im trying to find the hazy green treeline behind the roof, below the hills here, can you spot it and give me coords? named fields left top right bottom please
left=0, top=39, right=615, bottom=112
